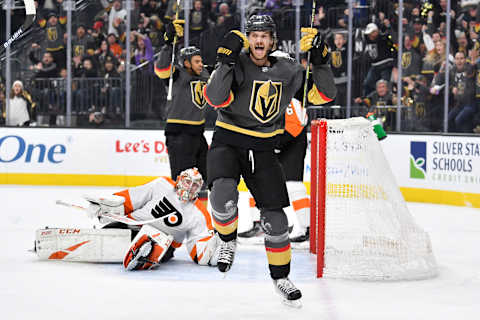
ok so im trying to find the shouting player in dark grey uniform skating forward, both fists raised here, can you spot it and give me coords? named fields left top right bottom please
left=204, top=15, right=336, bottom=304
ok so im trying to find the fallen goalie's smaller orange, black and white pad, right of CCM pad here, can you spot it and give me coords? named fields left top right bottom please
left=123, top=225, right=173, bottom=271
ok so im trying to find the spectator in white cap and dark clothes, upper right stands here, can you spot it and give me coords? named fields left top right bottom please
left=363, top=23, right=396, bottom=96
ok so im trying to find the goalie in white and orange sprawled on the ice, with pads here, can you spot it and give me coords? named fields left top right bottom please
left=34, top=168, right=218, bottom=270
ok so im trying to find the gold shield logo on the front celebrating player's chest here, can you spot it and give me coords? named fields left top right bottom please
left=249, top=80, right=282, bottom=123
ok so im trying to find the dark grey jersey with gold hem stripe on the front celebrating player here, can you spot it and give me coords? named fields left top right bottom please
left=204, top=52, right=336, bottom=150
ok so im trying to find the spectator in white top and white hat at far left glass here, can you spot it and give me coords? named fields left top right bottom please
left=5, top=80, right=35, bottom=127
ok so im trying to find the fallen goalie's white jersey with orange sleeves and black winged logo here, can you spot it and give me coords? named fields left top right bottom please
left=115, top=177, right=217, bottom=265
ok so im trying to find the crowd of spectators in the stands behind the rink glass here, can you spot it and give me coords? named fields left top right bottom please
left=0, top=0, right=480, bottom=133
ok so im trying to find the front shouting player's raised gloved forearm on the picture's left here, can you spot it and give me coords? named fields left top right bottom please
left=203, top=30, right=248, bottom=108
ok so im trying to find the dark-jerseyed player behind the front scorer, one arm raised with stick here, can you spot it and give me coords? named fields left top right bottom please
left=155, top=20, right=209, bottom=204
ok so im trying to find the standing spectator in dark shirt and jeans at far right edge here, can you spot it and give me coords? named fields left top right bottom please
left=448, top=51, right=477, bottom=133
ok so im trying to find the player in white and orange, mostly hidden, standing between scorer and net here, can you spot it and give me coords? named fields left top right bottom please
left=238, top=97, right=310, bottom=242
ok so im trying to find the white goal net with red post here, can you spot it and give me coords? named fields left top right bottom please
left=310, top=117, right=437, bottom=280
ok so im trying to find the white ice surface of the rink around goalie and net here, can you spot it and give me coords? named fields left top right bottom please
left=0, top=185, right=480, bottom=320
